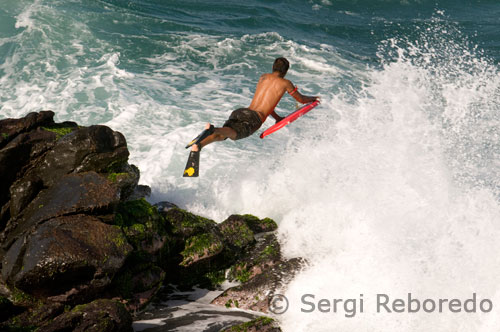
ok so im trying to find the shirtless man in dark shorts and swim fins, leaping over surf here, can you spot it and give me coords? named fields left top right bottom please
left=184, top=58, right=318, bottom=176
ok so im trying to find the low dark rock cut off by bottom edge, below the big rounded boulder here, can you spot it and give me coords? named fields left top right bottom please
left=37, top=300, right=132, bottom=332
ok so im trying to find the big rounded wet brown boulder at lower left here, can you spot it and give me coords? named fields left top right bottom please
left=2, top=214, right=132, bottom=303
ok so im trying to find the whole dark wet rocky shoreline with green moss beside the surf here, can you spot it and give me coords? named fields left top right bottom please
left=0, top=111, right=304, bottom=332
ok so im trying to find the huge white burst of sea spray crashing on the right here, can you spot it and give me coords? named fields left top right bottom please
left=274, top=20, right=500, bottom=331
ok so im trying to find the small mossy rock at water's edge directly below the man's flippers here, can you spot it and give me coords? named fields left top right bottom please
left=162, top=207, right=217, bottom=239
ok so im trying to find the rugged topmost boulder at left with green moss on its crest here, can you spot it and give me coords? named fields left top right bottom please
left=0, top=122, right=127, bottom=228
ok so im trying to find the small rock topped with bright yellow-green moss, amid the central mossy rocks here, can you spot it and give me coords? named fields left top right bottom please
left=180, top=233, right=223, bottom=267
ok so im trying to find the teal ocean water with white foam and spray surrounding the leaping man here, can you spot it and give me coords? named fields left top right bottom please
left=0, top=0, right=500, bottom=332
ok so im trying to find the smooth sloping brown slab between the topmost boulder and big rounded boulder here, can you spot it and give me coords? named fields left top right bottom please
left=0, top=172, right=120, bottom=250
